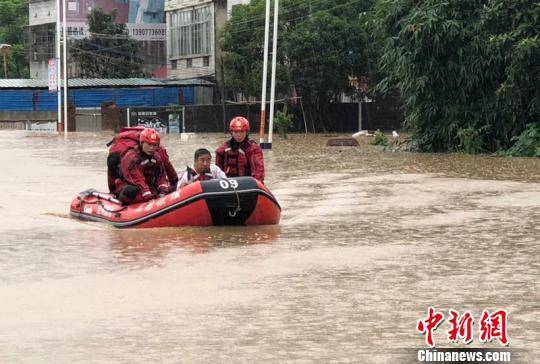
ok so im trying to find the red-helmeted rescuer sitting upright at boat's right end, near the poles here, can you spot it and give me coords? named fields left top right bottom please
left=216, top=116, right=264, bottom=182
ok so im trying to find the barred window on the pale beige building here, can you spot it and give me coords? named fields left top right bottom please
left=169, top=5, right=212, bottom=57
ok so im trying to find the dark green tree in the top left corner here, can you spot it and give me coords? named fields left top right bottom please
left=0, top=0, right=30, bottom=78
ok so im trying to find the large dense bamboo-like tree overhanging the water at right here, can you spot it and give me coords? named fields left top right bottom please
left=374, top=0, right=540, bottom=153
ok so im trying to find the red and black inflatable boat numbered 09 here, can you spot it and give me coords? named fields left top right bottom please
left=71, top=177, right=281, bottom=228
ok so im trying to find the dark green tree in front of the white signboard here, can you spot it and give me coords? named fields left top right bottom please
left=70, top=8, right=145, bottom=78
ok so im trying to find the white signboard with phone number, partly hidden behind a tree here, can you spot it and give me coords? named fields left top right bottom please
left=67, top=22, right=167, bottom=41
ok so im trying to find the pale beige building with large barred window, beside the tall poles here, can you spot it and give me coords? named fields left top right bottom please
left=165, top=0, right=227, bottom=96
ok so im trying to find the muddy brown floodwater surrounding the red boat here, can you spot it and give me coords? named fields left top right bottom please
left=0, top=131, right=540, bottom=363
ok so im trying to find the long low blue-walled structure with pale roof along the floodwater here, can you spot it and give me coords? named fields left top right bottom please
left=0, top=78, right=214, bottom=131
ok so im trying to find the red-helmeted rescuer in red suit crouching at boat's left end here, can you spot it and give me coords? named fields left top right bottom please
left=115, top=128, right=169, bottom=204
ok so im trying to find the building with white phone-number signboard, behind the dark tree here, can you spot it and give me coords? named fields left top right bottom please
left=28, top=0, right=166, bottom=79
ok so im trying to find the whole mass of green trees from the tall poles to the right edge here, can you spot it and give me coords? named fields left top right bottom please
left=221, top=0, right=540, bottom=154
